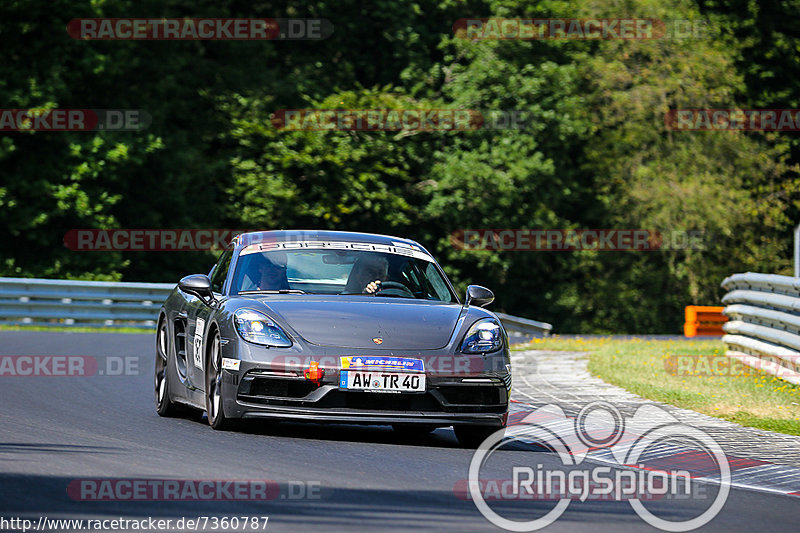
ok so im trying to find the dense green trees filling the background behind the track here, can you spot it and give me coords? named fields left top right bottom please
left=0, top=0, right=800, bottom=332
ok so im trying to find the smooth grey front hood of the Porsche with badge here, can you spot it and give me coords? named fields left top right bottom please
left=250, top=296, right=463, bottom=350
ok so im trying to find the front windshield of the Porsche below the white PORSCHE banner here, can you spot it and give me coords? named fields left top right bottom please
left=233, top=244, right=456, bottom=302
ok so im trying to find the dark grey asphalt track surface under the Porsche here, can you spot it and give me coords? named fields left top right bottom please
left=0, top=331, right=800, bottom=533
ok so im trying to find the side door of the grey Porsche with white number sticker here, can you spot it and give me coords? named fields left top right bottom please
left=186, top=245, right=233, bottom=390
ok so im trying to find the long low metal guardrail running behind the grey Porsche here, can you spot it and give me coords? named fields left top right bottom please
left=0, top=278, right=553, bottom=337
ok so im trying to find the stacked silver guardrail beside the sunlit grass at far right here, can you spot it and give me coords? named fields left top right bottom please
left=722, top=272, right=800, bottom=385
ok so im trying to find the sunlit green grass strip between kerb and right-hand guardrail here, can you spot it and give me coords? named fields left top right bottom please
left=515, top=336, right=800, bottom=435
